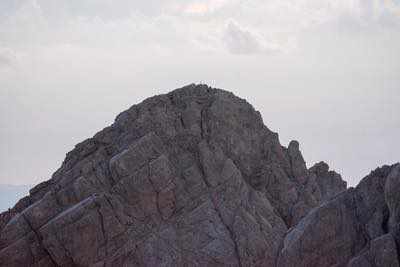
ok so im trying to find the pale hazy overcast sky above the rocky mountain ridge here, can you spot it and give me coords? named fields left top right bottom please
left=0, top=0, right=400, bottom=188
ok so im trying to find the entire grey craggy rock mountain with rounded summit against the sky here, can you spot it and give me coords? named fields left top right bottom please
left=0, top=84, right=400, bottom=267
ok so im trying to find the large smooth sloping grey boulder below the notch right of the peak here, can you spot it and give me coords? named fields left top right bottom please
left=278, top=189, right=367, bottom=266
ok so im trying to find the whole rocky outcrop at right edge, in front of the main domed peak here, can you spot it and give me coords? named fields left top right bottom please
left=278, top=164, right=400, bottom=266
